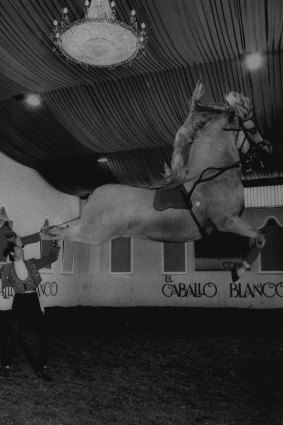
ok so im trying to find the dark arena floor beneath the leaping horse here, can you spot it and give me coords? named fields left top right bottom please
left=0, top=307, right=283, bottom=425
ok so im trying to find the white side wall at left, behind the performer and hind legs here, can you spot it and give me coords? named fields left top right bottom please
left=0, top=154, right=80, bottom=309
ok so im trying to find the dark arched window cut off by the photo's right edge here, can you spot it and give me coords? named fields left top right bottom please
left=259, top=217, right=283, bottom=273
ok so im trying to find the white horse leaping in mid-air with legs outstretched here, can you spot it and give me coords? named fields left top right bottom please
left=45, top=82, right=270, bottom=280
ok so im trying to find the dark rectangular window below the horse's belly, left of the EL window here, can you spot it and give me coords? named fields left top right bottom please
left=110, top=238, right=133, bottom=273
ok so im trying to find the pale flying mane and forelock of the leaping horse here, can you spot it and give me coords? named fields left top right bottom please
left=164, top=81, right=252, bottom=185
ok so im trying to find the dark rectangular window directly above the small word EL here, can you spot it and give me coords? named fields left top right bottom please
left=162, top=242, right=187, bottom=274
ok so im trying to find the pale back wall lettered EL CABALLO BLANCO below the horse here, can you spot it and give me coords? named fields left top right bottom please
left=77, top=208, right=283, bottom=308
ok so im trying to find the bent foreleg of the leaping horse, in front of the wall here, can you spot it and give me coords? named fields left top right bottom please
left=218, top=217, right=265, bottom=282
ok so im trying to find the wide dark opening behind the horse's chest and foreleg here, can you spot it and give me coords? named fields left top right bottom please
left=194, top=232, right=250, bottom=271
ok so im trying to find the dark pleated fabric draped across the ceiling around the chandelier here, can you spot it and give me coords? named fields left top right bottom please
left=0, top=0, right=283, bottom=197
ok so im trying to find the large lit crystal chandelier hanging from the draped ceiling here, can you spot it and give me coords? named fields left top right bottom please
left=50, top=0, right=148, bottom=68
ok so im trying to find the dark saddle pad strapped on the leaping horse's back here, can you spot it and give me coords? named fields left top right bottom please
left=153, top=185, right=188, bottom=211
